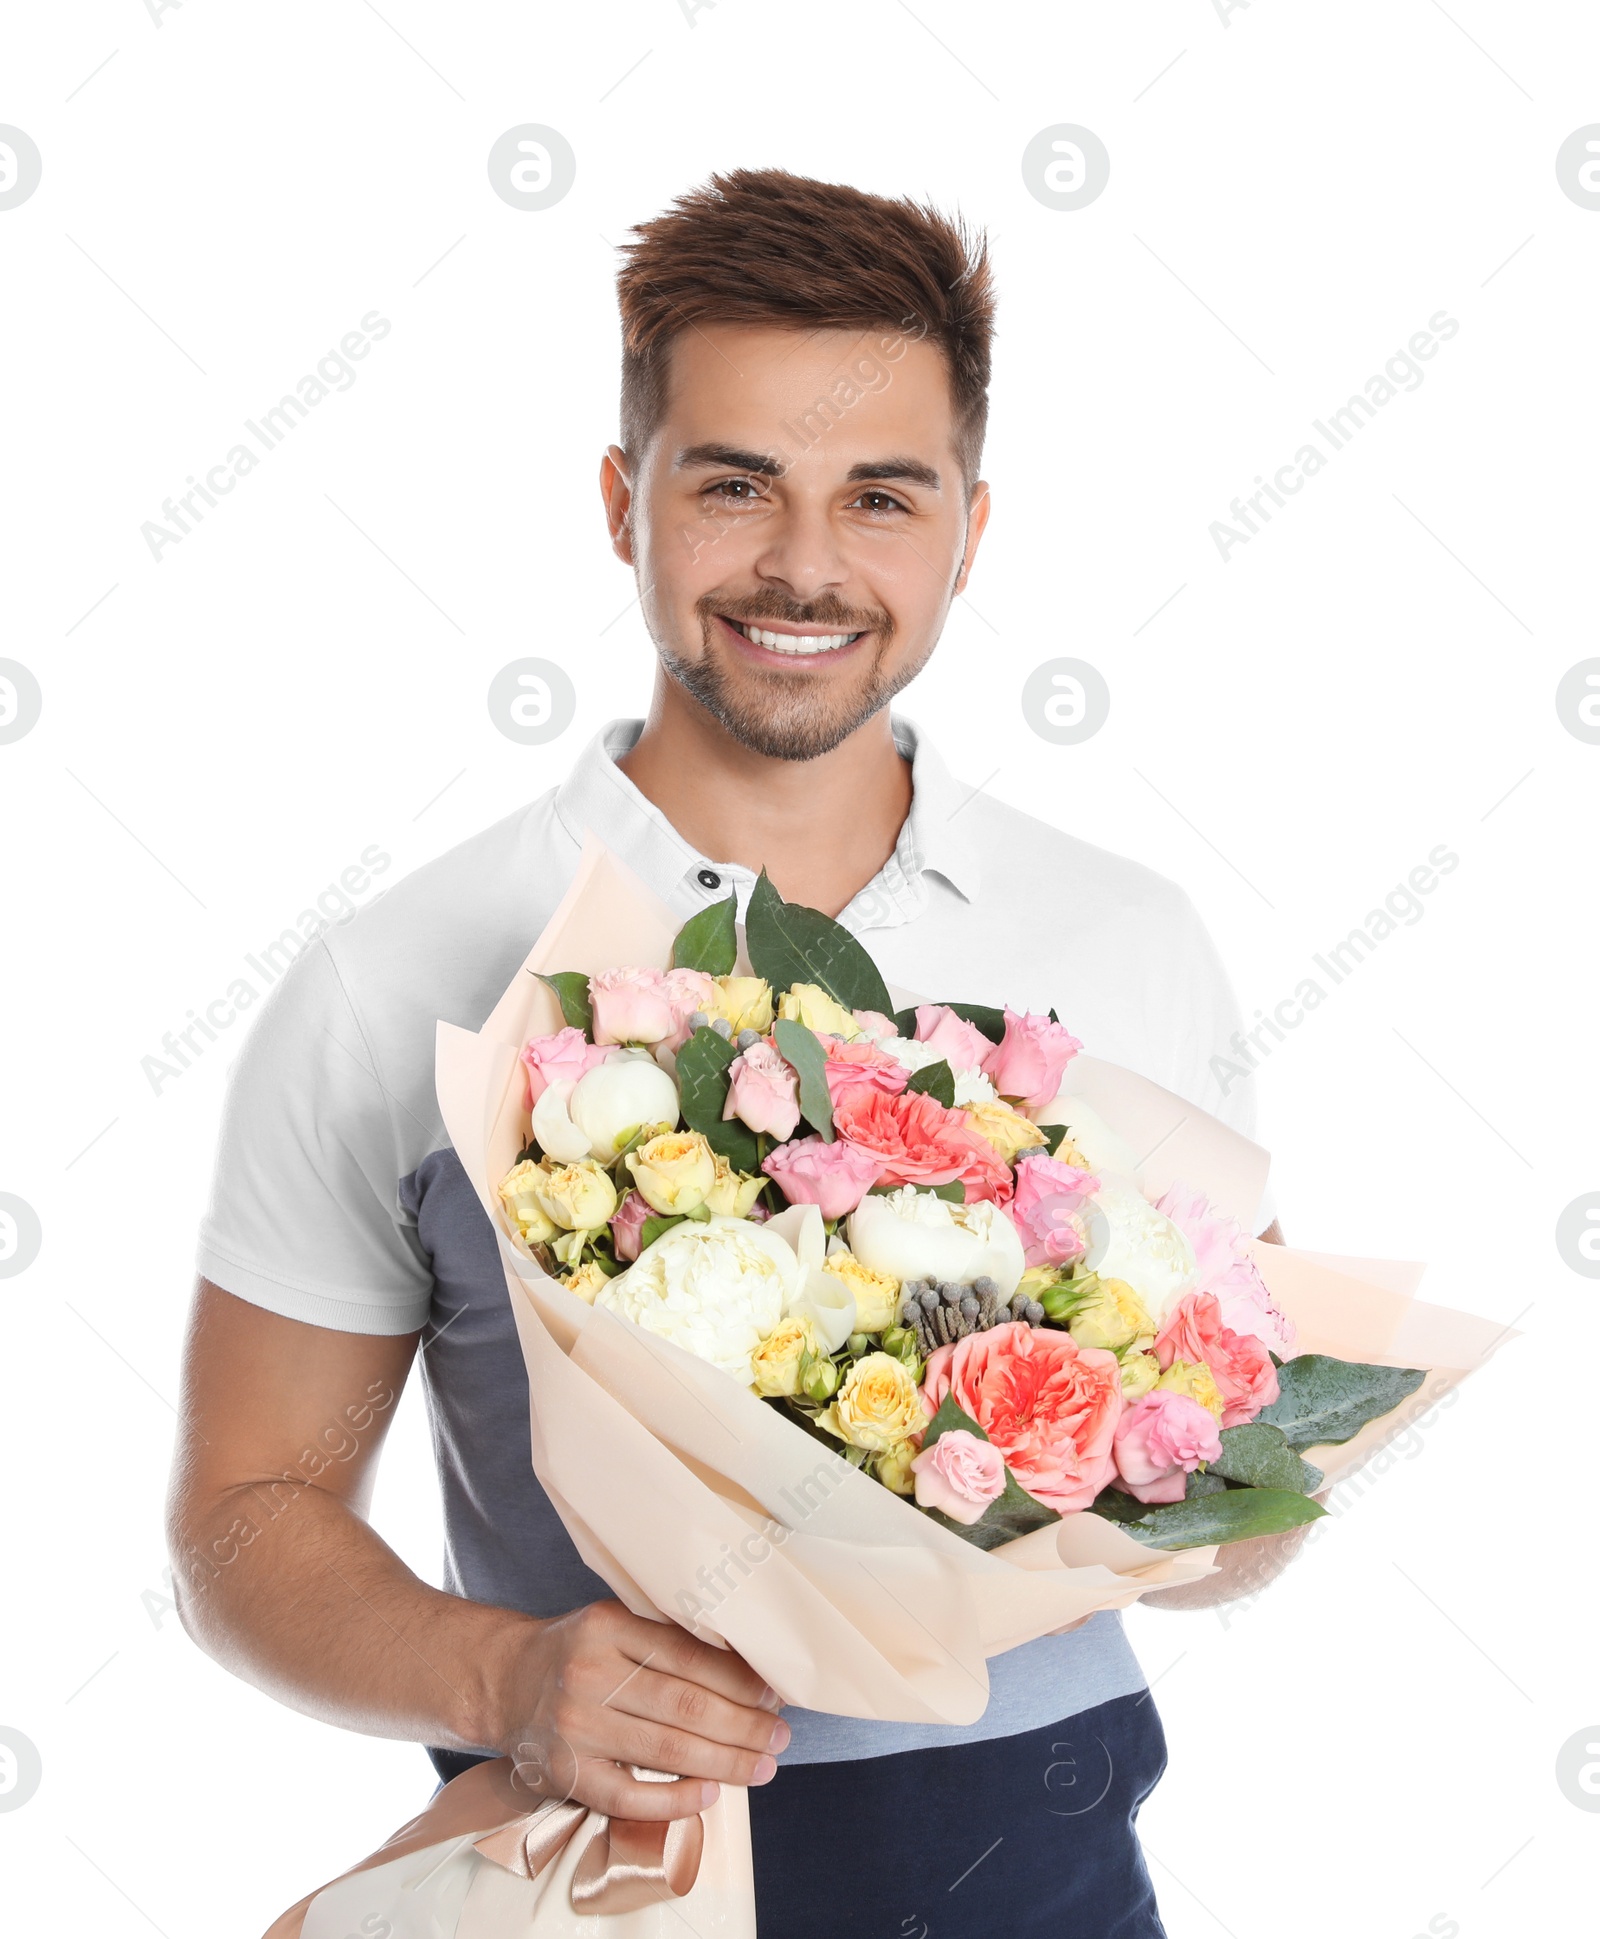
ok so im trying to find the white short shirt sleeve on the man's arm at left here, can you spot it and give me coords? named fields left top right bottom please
left=200, top=942, right=432, bottom=1334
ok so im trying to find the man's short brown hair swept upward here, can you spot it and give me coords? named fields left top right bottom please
left=617, top=169, right=995, bottom=483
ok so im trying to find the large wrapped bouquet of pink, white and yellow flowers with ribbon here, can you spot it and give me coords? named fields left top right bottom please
left=270, top=845, right=1505, bottom=1939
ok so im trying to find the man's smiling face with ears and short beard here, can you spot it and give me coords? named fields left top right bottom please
left=601, top=324, right=989, bottom=760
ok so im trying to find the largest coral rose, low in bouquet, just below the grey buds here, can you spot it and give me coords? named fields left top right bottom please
left=923, top=1320, right=1123, bottom=1514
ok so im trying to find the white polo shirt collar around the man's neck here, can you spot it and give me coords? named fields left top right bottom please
left=555, top=717, right=981, bottom=927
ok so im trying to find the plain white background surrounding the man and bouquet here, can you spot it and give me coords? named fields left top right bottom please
left=0, top=0, right=1600, bottom=1939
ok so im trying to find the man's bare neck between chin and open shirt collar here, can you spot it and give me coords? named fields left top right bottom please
left=619, top=669, right=912, bottom=915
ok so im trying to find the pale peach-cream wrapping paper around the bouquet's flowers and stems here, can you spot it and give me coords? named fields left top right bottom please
left=270, top=843, right=1507, bottom=1939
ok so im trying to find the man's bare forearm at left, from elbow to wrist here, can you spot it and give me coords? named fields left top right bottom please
left=173, top=1485, right=539, bottom=1751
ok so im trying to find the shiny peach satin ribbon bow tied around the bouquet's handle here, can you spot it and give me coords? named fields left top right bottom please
left=266, top=1757, right=706, bottom=1939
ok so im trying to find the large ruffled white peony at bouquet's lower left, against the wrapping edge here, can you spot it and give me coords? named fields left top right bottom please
left=595, top=1206, right=830, bottom=1386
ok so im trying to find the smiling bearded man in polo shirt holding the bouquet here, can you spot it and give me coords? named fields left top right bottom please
left=171, top=173, right=1295, bottom=1939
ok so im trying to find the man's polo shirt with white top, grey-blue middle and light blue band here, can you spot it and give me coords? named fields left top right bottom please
left=200, top=721, right=1263, bottom=1763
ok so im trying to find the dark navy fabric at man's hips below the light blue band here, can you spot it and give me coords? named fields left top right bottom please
left=429, top=1691, right=1168, bottom=1939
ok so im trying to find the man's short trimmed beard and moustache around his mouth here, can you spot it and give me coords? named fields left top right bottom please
left=657, top=595, right=933, bottom=760
